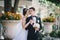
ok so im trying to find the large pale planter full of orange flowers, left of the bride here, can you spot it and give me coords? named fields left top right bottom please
left=0, top=12, right=22, bottom=38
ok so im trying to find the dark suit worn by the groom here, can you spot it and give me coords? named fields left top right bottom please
left=26, top=16, right=42, bottom=40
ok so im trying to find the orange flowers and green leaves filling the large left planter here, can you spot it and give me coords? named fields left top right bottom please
left=0, top=12, right=22, bottom=20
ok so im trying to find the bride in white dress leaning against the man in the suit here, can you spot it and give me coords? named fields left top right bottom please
left=13, top=8, right=30, bottom=40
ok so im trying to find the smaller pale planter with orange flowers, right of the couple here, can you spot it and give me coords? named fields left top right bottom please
left=42, top=16, right=56, bottom=33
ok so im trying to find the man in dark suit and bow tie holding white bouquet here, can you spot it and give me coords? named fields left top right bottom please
left=26, top=7, right=42, bottom=40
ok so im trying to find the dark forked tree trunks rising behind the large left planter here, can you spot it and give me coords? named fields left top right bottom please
left=4, top=0, right=19, bottom=13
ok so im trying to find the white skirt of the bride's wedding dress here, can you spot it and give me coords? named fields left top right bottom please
left=13, top=19, right=28, bottom=40
